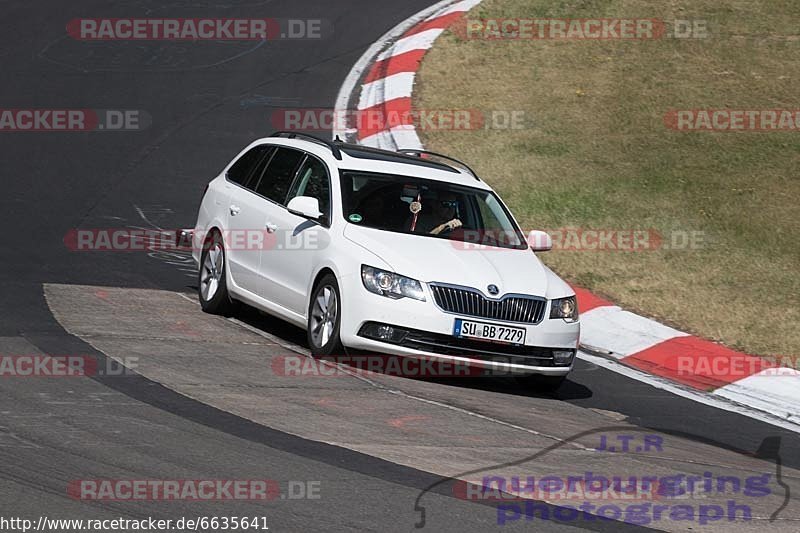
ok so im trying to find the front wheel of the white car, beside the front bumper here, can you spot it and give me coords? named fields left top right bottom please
left=306, top=274, right=344, bottom=356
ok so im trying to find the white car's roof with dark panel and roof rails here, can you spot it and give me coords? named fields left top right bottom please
left=253, top=136, right=491, bottom=190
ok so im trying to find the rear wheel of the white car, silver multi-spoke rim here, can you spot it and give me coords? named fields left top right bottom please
left=197, top=232, right=236, bottom=316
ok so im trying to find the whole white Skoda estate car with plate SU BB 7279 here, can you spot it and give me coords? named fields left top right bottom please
left=184, top=132, right=580, bottom=387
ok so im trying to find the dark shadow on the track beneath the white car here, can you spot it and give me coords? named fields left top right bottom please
left=222, top=305, right=592, bottom=401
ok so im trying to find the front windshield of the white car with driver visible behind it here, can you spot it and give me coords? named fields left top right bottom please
left=341, top=171, right=528, bottom=249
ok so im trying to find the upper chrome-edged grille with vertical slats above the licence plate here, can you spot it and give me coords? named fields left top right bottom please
left=430, top=283, right=547, bottom=324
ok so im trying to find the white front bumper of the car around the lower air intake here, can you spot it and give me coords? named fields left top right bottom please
left=341, top=279, right=580, bottom=376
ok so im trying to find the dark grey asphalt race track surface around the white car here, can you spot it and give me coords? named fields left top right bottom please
left=0, top=0, right=800, bottom=531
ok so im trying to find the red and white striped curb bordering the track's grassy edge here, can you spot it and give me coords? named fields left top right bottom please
left=334, top=0, right=800, bottom=432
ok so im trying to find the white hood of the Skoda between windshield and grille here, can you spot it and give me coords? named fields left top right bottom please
left=344, top=224, right=573, bottom=298
